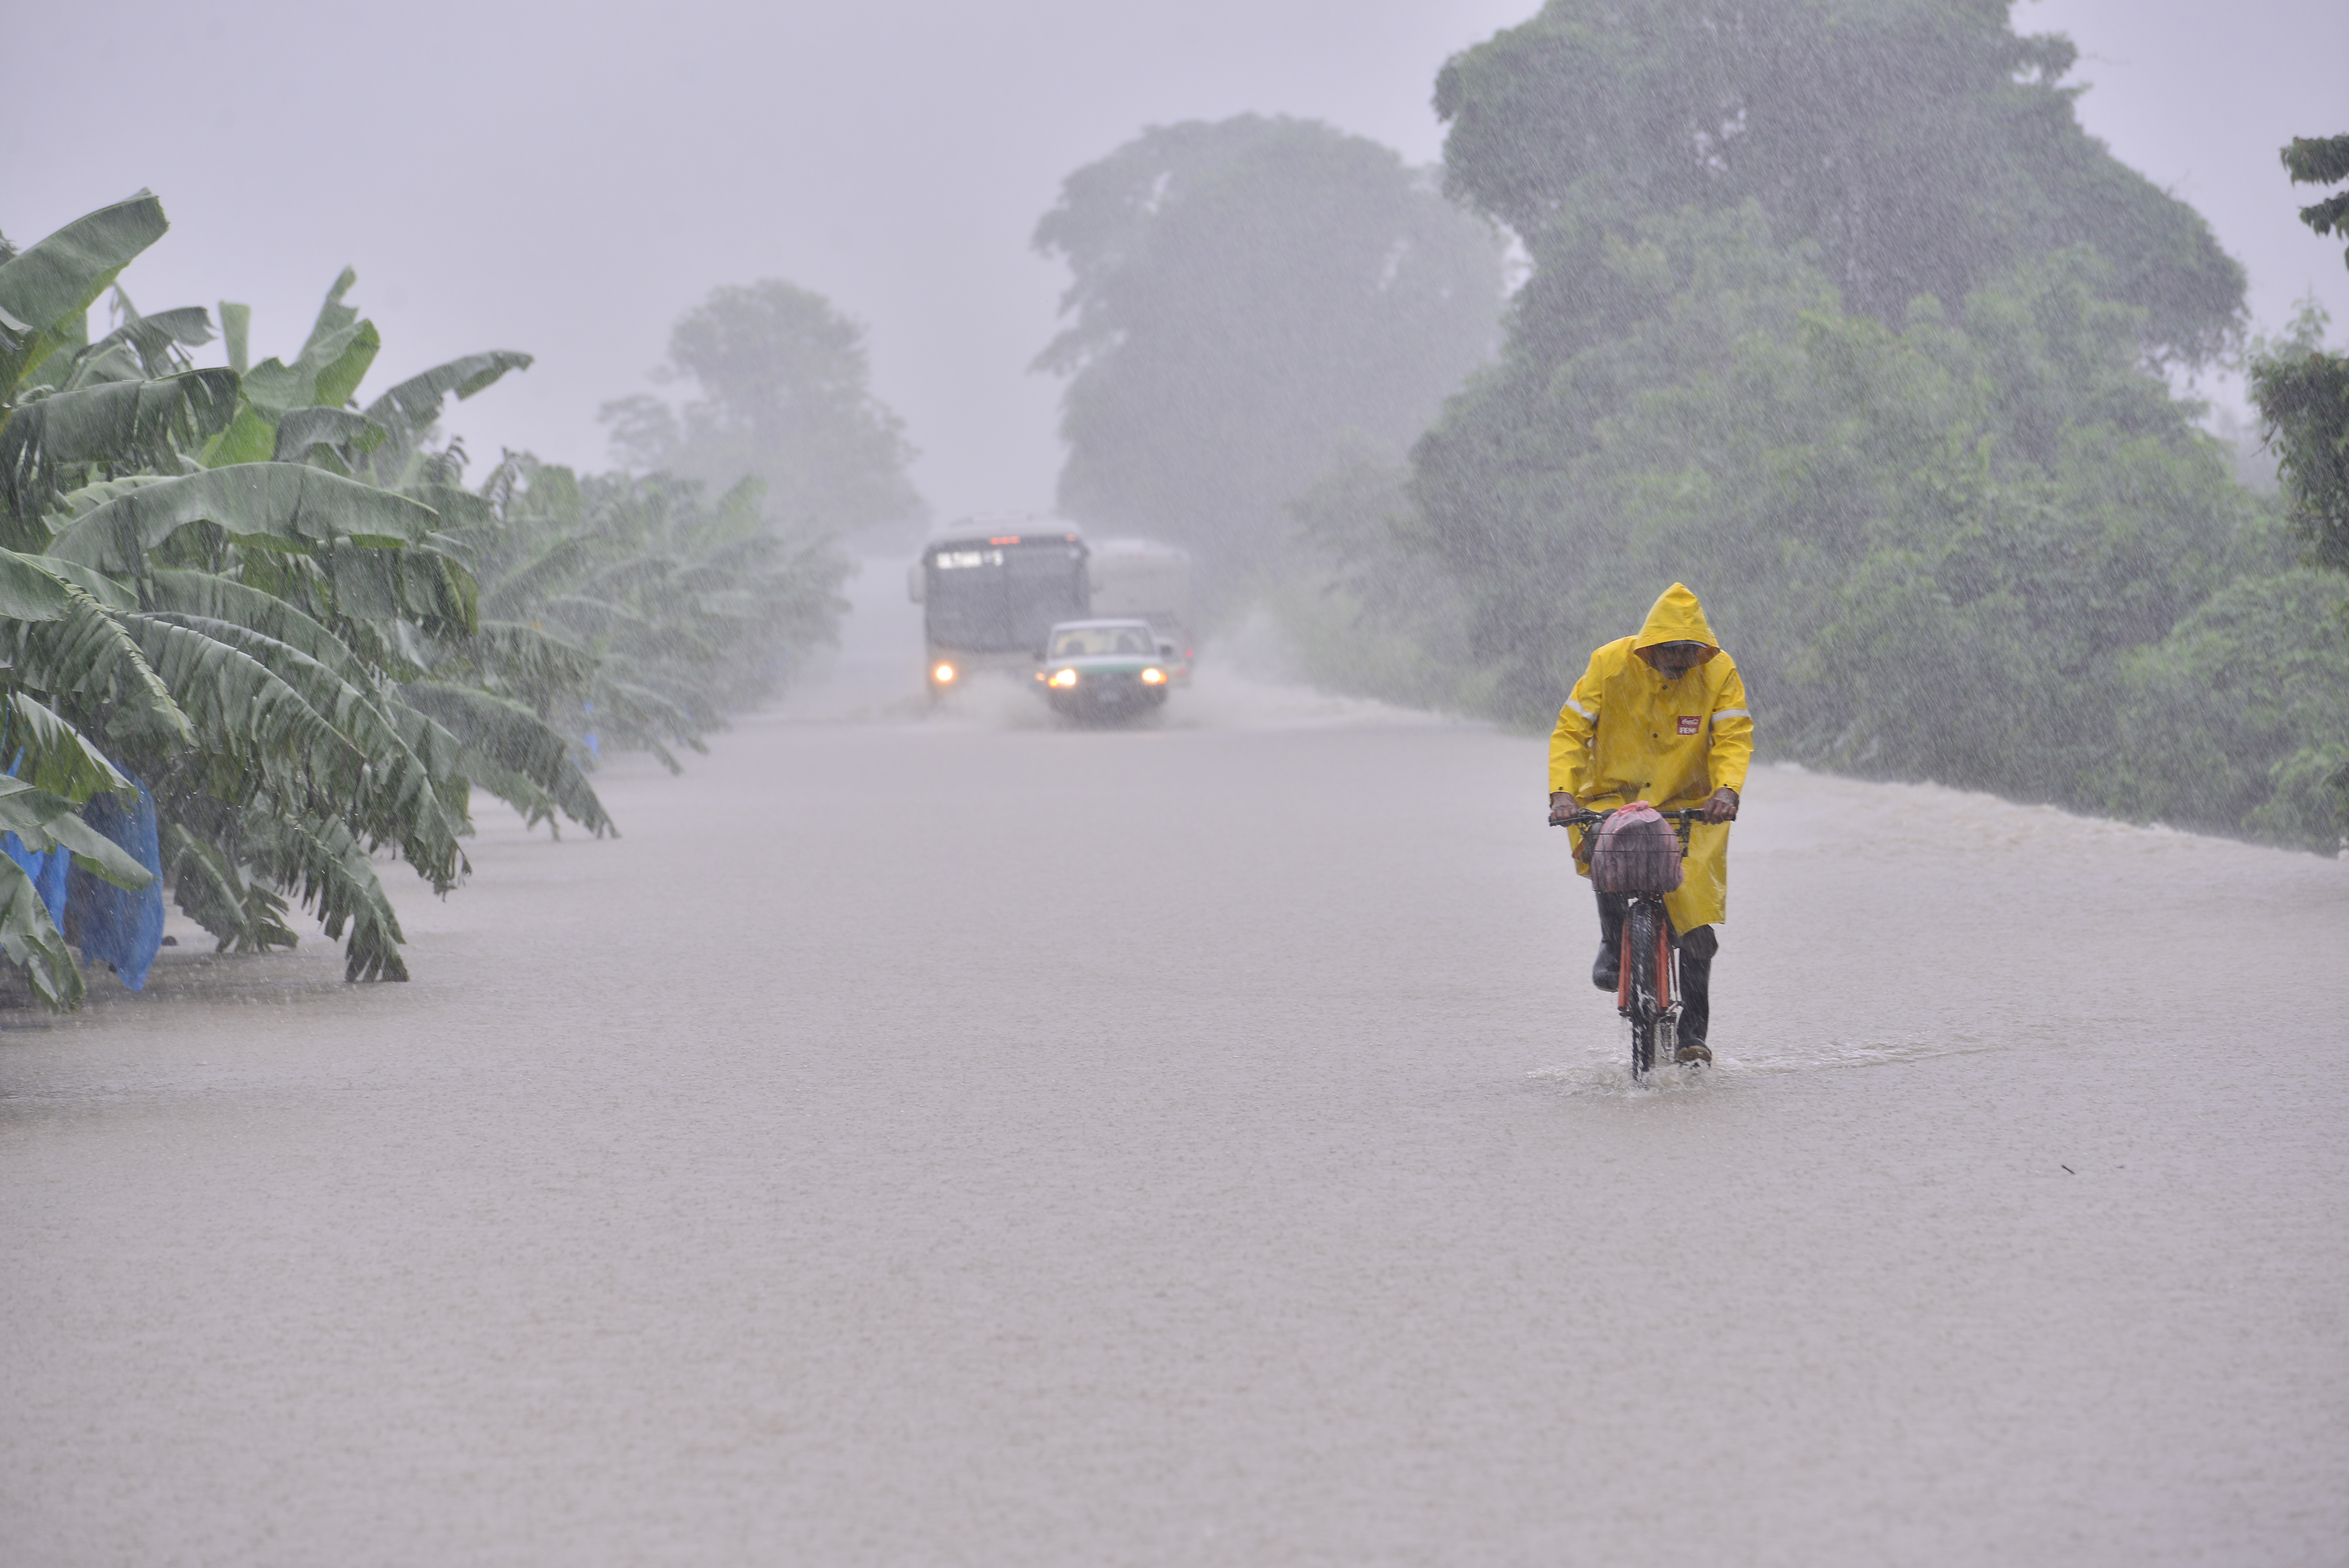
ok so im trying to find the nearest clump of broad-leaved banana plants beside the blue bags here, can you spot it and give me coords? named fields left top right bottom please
left=0, top=192, right=608, bottom=1007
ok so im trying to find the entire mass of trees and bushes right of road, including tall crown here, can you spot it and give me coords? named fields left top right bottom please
left=1325, top=0, right=2349, bottom=850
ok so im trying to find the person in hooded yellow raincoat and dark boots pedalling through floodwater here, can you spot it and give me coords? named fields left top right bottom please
left=1551, top=582, right=1755, bottom=1061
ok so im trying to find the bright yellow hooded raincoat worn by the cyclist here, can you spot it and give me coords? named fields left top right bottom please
left=1551, top=582, right=1755, bottom=932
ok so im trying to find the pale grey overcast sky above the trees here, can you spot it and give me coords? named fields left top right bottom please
left=18, top=0, right=2349, bottom=519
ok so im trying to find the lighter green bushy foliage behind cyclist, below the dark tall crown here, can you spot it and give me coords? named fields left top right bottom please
left=1393, top=204, right=2309, bottom=843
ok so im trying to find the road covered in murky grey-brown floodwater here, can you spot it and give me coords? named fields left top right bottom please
left=0, top=596, right=2349, bottom=1566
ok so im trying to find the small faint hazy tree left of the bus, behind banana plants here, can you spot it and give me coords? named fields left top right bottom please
left=604, top=277, right=923, bottom=533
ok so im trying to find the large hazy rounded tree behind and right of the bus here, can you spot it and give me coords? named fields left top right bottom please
left=1036, top=115, right=1501, bottom=594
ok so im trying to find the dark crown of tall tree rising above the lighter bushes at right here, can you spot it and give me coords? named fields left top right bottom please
left=1435, top=0, right=2243, bottom=364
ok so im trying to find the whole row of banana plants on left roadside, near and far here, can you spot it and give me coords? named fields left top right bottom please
left=0, top=195, right=841, bottom=1007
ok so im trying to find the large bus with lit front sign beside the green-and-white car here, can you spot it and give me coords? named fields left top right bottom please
left=907, top=517, right=1092, bottom=697
